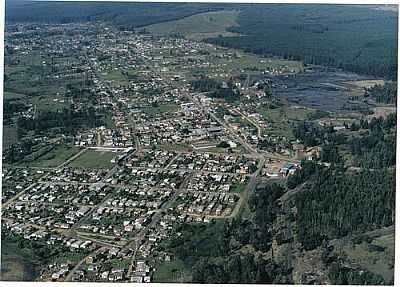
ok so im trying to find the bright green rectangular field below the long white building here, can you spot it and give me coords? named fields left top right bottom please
left=69, top=150, right=117, bottom=169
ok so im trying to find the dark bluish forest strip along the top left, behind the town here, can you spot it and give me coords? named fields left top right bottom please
left=6, top=0, right=221, bottom=29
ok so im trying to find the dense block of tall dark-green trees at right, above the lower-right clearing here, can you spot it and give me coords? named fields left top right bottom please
left=296, top=168, right=395, bottom=250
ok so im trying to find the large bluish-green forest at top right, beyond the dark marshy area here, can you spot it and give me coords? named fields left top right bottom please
left=208, top=5, right=397, bottom=79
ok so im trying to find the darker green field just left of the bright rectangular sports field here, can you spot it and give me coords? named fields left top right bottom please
left=29, top=145, right=79, bottom=167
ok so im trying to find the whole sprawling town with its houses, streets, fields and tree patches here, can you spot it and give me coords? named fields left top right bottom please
left=1, top=3, right=395, bottom=283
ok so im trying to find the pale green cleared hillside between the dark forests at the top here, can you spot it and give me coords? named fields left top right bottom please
left=145, top=10, right=239, bottom=39
